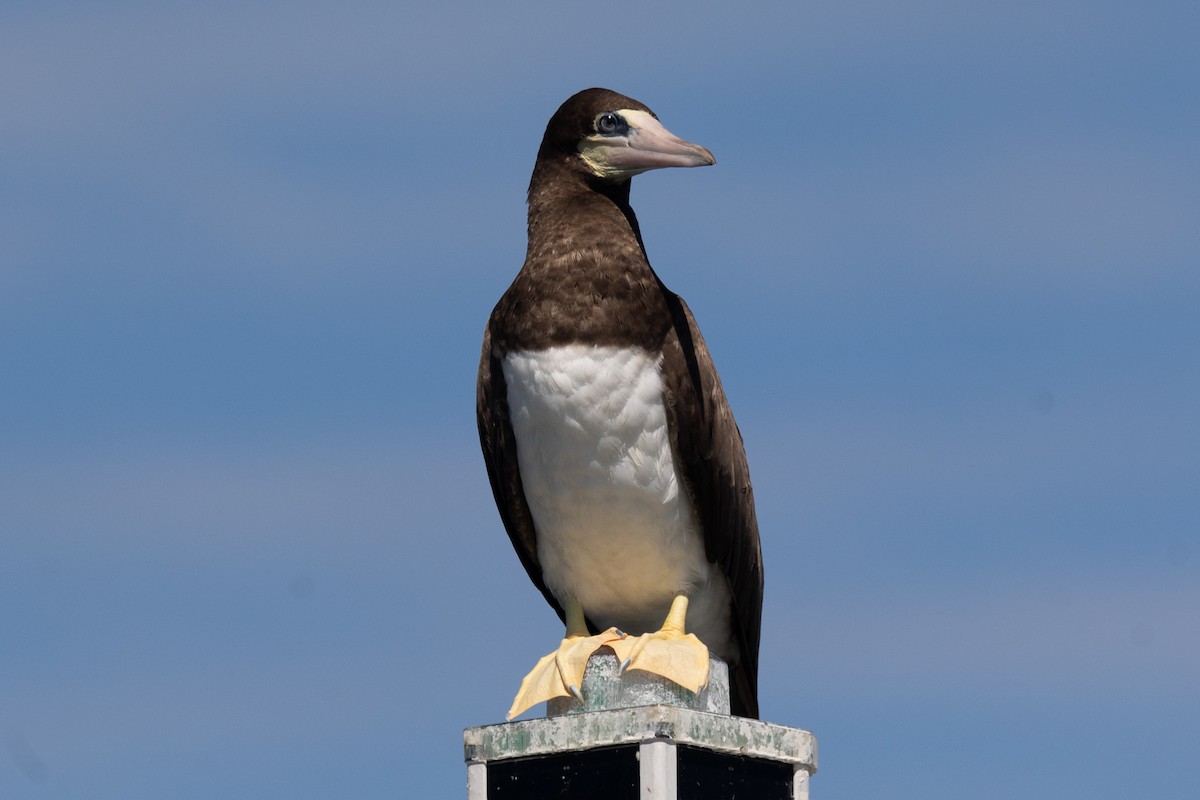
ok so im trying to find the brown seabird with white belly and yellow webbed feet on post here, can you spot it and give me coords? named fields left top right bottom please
left=476, top=89, right=763, bottom=720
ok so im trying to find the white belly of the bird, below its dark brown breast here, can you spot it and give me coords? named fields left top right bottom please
left=504, top=345, right=734, bottom=658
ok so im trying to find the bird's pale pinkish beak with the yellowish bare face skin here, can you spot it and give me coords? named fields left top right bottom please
left=580, top=109, right=716, bottom=180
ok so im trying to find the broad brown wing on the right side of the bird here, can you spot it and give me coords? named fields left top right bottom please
left=662, top=288, right=762, bottom=718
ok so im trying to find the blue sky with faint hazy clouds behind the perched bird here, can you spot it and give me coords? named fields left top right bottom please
left=0, top=0, right=1200, bottom=800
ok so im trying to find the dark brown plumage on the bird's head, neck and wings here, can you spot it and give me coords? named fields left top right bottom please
left=476, top=89, right=762, bottom=717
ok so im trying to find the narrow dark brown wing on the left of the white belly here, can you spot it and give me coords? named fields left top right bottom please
left=475, top=330, right=564, bottom=619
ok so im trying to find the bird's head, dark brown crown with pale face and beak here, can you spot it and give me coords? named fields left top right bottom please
left=538, top=89, right=716, bottom=184
